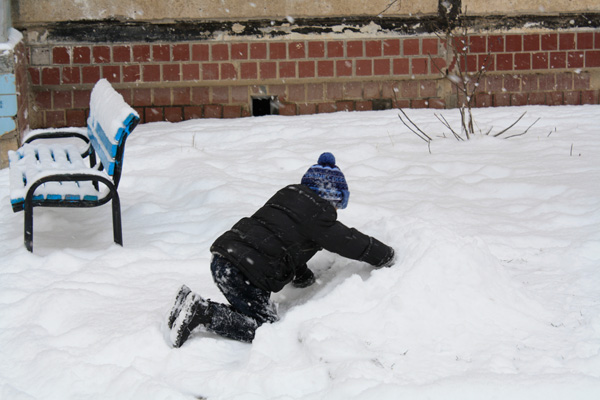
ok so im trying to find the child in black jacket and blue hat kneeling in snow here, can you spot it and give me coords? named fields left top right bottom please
left=167, top=153, right=394, bottom=347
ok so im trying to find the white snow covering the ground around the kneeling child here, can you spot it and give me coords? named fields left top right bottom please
left=0, top=106, right=600, bottom=400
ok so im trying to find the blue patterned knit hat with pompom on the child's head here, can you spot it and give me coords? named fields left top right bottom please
left=300, top=153, right=350, bottom=209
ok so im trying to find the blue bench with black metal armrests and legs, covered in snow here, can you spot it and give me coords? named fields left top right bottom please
left=8, top=79, right=140, bottom=251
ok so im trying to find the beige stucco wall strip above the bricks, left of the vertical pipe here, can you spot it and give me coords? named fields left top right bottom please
left=13, top=0, right=438, bottom=25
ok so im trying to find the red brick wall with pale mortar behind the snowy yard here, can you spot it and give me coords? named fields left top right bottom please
left=27, top=30, right=600, bottom=127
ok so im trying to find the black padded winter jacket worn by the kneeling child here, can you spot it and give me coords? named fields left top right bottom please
left=210, top=185, right=393, bottom=292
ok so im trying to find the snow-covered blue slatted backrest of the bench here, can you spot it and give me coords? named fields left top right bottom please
left=88, top=79, right=140, bottom=185
